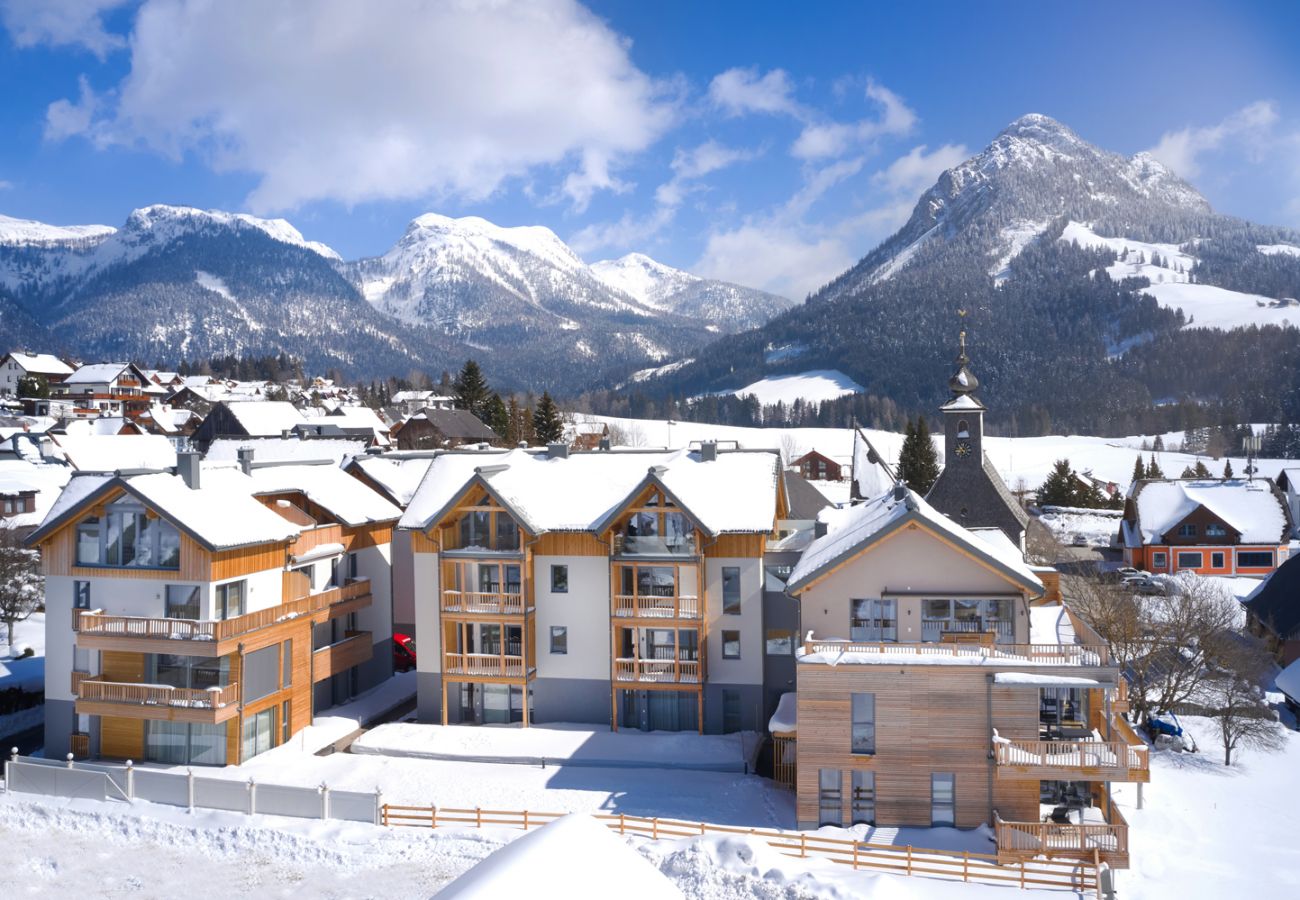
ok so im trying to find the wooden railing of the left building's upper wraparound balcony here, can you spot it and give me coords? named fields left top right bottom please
left=77, top=579, right=371, bottom=641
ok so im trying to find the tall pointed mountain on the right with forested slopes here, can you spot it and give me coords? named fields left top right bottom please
left=640, top=114, right=1300, bottom=432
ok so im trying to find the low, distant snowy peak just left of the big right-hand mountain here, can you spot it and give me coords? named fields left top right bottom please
left=592, top=254, right=793, bottom=332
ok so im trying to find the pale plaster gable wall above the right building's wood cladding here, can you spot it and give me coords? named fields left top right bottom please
left=798, top=529, right=1028, bottom=642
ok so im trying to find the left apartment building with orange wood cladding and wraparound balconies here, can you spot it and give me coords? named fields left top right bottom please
left=29, top=454, right=400, bottom=765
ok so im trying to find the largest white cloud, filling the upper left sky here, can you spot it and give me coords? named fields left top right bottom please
left=47, top=0, right=676, bottom=212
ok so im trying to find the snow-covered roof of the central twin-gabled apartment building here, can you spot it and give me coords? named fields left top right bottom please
left=402, top=450, right=780, bottom=535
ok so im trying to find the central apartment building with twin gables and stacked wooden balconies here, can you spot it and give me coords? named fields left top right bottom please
left=400, top=443, right=811, bottom=732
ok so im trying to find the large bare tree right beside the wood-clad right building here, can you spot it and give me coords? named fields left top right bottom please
left=1069, top=577, right=1242, bottom=719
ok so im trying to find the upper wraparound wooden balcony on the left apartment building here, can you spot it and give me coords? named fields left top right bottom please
left=74, top=579, right=372, bottom=657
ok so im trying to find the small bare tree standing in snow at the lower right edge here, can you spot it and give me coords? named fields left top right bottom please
left=1199, top=635, right=1286, bottom=766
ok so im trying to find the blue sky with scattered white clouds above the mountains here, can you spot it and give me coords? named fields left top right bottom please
left=0, top=0, right=1300, bottom=297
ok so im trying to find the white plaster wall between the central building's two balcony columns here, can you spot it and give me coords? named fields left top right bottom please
left=533, top=557, right=610, bottom=682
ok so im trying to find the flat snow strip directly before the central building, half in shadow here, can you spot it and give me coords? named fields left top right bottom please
left=352, top=722, right=758, bottom=773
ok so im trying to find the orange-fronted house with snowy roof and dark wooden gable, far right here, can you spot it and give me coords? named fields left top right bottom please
left=1119, top=479, right=1291, bottom=575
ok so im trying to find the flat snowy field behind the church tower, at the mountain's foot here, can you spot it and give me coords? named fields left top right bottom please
left=579, top=416, right=1296, bottom=489
